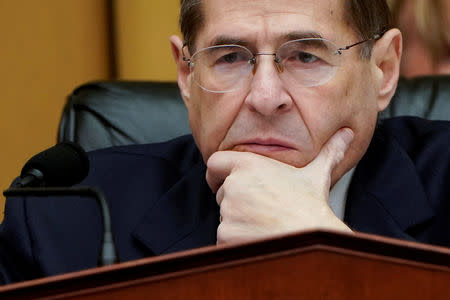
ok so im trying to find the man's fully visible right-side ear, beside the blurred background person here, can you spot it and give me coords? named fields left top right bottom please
left=372, top=29, right=403, bottom=111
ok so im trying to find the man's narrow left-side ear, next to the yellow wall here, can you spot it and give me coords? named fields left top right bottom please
left=169, top=35, right=190, bottom=105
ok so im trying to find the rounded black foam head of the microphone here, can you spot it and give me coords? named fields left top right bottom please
left=20, top=142, right=89, bottom=187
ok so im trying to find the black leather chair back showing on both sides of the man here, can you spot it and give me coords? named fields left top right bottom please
left=58, top=76, right=450, bottom=151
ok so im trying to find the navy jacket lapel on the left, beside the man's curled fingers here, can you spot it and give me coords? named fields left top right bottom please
left=133, top=162, right=219, bottom=255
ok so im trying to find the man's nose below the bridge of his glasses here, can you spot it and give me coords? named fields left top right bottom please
left=245, top=55, right=293, bottom=116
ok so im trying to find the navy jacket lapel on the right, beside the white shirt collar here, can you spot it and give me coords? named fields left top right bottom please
left=345, top=127, right=434, bottom=239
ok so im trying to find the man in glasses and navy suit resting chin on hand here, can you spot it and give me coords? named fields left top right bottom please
left=0, top=0, right=450, bottom=282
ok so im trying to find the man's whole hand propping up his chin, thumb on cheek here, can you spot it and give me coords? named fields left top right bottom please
left=206, top=128, right=353, bottom=244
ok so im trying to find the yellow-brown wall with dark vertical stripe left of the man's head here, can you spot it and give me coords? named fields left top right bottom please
left=0, top=0, right=179, bottom=220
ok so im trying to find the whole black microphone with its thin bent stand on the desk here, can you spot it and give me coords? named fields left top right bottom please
left=3, top=142, right=119, bottom=266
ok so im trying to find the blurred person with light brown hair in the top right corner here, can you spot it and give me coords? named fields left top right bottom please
left=388, top=0, right=450, bottom=77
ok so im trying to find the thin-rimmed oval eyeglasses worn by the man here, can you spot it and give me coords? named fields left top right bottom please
left=182, top=32, right=384, bottom=93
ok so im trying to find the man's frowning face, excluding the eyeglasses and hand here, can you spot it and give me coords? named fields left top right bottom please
left=179, top=0, right=386, bottom=183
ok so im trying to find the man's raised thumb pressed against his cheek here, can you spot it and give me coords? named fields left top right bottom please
left=308, top=128, right=354, bottom=175
